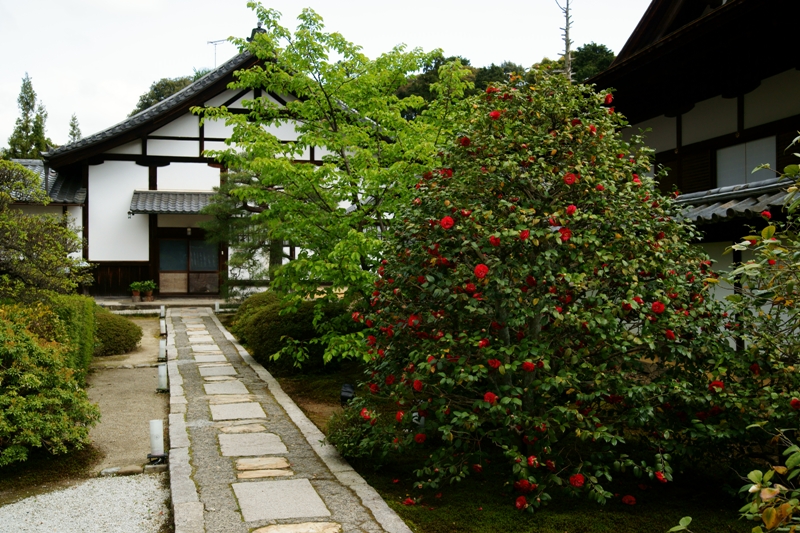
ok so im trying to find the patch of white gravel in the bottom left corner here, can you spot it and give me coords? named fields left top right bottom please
left=0, top=473, right=169, bottom=533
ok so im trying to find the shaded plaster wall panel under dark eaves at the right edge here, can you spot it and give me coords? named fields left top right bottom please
left=744, top=69, right=800, bottom=128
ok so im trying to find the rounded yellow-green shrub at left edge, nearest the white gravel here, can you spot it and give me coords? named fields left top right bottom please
left=0, top=316, right=100, bottom=466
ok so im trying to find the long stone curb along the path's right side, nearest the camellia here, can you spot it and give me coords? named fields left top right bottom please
left=208, top=313, right=412, bottom=533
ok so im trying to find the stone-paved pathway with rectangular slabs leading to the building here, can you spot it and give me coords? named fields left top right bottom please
left=167, top=308, right=411, bottom=533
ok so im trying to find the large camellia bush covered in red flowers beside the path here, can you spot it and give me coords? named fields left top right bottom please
left=330, top=73, right=796, bottom=510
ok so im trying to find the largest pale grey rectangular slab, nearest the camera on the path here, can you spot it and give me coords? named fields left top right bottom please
left=231, top=479, right=331, bottom=522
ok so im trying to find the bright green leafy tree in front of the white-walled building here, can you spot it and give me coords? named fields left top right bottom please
left=195, top=3, right=469, bottom=346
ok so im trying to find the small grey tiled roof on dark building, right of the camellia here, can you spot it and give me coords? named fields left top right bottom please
left=675, top=178, right=792, bottom=224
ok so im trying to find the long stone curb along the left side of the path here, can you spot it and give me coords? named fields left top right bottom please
left=166, top=308, right=206, bottom=533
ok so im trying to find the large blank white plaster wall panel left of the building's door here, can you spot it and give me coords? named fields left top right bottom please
left=89, top=161, right=149, bottom=261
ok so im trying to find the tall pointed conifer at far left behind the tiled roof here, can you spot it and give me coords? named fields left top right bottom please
left=4, top=73, right=52, bottom=159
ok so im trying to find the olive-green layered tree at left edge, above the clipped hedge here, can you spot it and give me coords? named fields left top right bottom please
left=0, top=161, right=92, bottom=301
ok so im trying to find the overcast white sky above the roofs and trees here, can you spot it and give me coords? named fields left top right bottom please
left=0, top=0, right=650, bottom=147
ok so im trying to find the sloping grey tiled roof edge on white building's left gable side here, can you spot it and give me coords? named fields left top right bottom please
left=44, top=52, right=253, bottom=159
